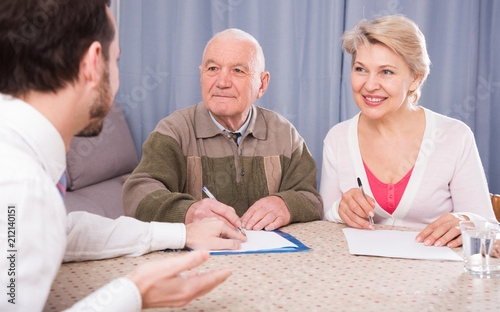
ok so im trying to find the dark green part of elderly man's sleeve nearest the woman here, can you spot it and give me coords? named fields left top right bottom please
left=270, top=143, right=323, bottom=223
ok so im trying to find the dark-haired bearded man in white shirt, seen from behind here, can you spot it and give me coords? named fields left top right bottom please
left=0, top=0, right=245, bottom=311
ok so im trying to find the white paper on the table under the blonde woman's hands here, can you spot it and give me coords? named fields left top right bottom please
left=342, top=228, right=462, bottom=261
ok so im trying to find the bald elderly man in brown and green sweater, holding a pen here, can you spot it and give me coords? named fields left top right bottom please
left=123, top=29, right=323, bottom=230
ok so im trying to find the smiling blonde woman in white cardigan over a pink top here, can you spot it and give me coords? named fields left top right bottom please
left=320, top=15, right=495, bottom=247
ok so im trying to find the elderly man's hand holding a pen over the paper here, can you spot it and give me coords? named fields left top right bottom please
left=185, top=198, right=241, bottom=227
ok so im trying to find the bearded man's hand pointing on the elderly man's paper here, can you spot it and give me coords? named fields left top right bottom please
left=186, top=218, right=247, bottom=250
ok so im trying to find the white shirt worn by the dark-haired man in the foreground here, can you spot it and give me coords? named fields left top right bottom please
left=0, top=94, right=186, bottom=311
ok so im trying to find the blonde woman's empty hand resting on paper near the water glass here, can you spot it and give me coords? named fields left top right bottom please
left=415, top=213, right=469, bottom=248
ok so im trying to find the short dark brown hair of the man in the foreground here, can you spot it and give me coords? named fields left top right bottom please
left=0, top=0, right=114, bottom=96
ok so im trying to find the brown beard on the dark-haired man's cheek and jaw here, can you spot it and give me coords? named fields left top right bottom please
left=76, top=68, right=113, bottom=137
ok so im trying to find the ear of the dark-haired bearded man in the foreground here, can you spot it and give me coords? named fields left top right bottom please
left=80, top=41, right=104, bottom=86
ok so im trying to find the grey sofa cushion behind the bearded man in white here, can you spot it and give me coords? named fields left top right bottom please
left=66, top=102, right=138, bottom=191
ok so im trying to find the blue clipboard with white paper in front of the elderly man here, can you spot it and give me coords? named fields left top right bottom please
left=210, top=230, right=310, bottom=255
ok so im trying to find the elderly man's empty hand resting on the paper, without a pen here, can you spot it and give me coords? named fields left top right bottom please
left=241, top=196, right=290, bottom=231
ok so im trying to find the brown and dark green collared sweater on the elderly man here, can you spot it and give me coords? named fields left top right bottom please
left=123, top=103, right=323, bottom=223
